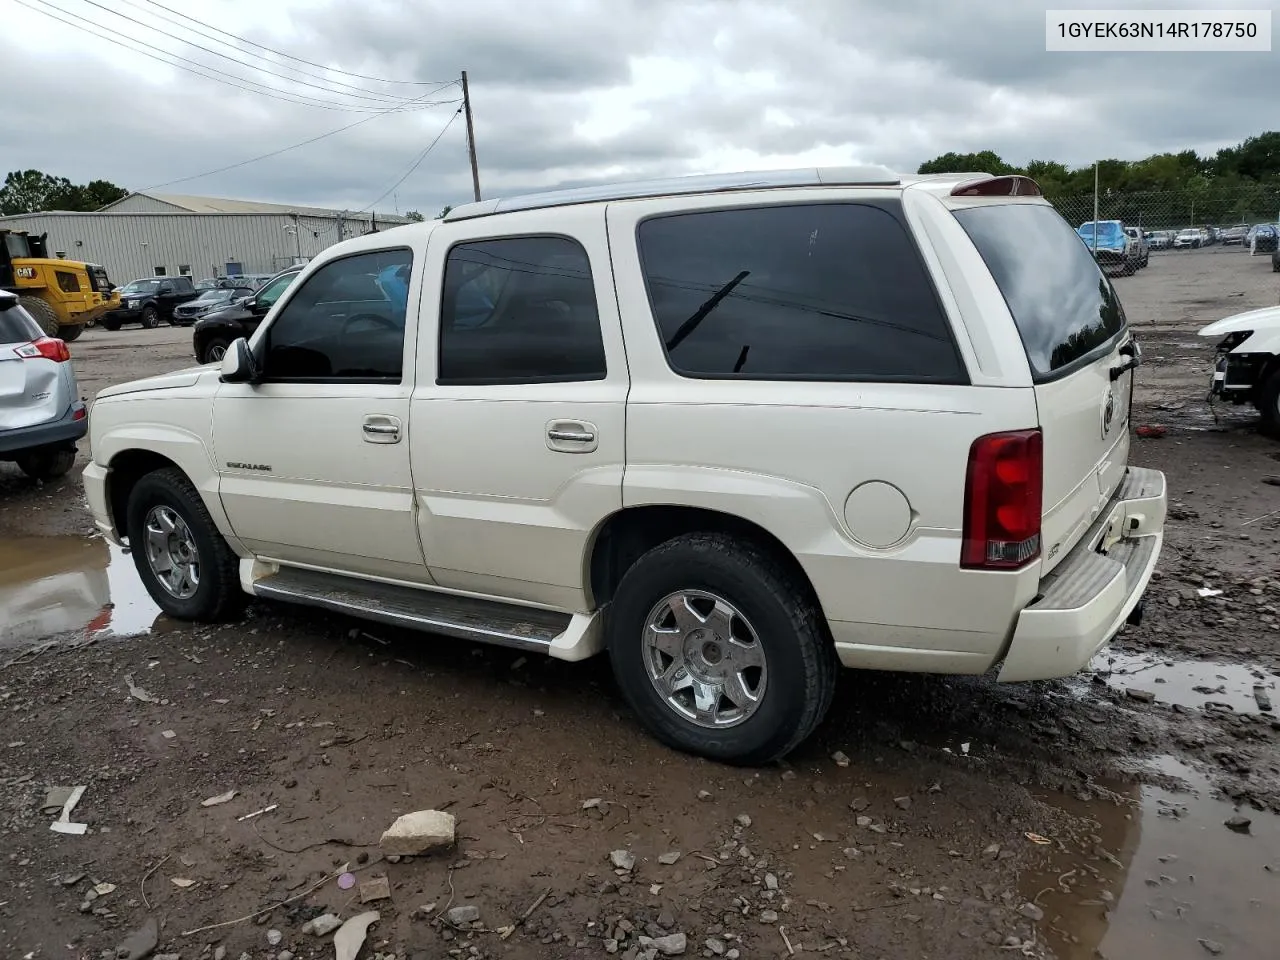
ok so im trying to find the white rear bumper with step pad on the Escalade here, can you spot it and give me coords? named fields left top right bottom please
left=998, top=467, right=1167, bottom=684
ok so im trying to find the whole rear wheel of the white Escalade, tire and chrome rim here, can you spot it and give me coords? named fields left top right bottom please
left=607, top=534, right=838, bottom=765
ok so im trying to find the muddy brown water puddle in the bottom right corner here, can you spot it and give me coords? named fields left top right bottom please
left=1021, top=758, right=1280, bottom=960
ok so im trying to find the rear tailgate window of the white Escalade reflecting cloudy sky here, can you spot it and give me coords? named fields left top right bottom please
left=955, top=204, right=1126, bottom=381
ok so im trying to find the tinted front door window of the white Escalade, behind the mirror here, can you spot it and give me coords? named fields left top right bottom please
left=264, top=250, right=413, bottom=383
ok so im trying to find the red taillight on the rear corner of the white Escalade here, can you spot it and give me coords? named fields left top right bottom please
left=960, top=430, right=1044, bottom=570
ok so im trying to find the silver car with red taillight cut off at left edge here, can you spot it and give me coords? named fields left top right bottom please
left=0, top=291, right=88, bottom=480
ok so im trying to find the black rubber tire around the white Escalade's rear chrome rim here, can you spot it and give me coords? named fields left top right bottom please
left=605, top=534, right=838, bottom=765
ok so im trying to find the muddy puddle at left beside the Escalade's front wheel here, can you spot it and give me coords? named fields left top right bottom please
left=0, top=536, right=168, bottom=648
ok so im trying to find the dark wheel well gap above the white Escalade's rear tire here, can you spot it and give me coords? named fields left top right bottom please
left=589, top=504, right=822, bottom=609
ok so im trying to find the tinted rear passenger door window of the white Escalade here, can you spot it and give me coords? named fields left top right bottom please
left=439, top=237, right=605, bottom=384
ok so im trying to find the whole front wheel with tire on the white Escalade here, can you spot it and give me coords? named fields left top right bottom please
left=127, top=468, right=243, bottom=621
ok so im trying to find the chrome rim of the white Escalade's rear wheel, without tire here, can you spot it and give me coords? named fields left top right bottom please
left=644, top=590, right=768, bottom=730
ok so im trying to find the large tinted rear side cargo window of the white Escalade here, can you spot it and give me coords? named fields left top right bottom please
left=639, top=204, right=965, bottom=383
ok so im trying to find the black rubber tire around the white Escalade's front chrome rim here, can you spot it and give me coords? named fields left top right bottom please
left=125, top=467, right=244, bottom=622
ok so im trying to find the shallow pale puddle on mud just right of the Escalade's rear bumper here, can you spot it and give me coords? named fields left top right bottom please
left=1078, top=650, right=1280, bottom=713
